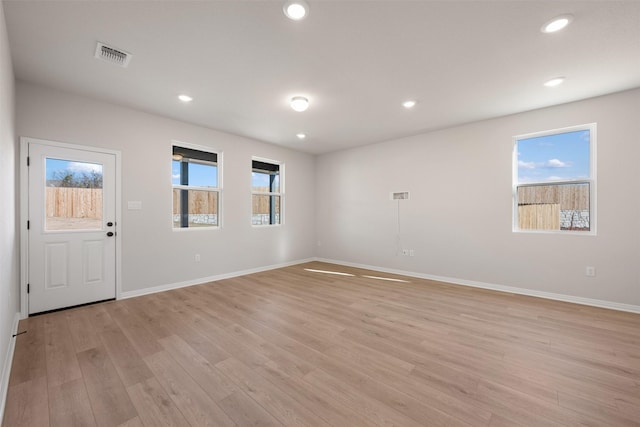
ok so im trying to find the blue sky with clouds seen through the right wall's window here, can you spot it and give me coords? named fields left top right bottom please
left=516, top=129, right=590, bottom=184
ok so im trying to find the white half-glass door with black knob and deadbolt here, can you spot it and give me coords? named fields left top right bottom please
left=28, top=142, right=116, bottom=314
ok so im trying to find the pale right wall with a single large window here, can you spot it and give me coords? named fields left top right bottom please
left=316, top=90, right=640, bottom=309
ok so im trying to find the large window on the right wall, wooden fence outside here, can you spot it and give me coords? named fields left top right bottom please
left=513, top=124, right=596, bottom=234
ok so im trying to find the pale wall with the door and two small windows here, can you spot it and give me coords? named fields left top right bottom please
left=16, top=82, right=315, bottom=293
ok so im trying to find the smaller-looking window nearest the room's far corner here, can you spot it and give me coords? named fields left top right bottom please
left=251, top=159, right=283, bottom=225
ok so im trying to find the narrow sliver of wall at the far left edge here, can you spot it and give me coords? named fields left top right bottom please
left=0, top=2, right=19, bottom=418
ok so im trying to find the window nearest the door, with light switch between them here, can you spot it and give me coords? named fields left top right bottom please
left=172, top=145, right=220, bottom=228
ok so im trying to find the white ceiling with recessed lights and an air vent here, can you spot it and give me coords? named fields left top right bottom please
left=3, top=0, right=640, bottom=153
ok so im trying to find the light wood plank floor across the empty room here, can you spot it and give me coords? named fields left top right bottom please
left=3, top=263, right=640, bottom=427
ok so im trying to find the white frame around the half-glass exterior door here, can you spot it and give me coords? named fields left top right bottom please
left=19, top=137, right=122, bottom=319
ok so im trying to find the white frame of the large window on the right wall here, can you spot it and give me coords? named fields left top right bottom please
left=512, top=123, right=597, bottom=236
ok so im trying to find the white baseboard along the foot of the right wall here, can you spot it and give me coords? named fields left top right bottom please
left=316, top=258, right=640, bottom=313
